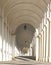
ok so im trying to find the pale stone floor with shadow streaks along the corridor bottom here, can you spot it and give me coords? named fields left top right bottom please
left=0, top=58, right=51, bottom=65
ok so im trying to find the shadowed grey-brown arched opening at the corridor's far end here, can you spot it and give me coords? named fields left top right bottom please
left=16, top=23, right=36, bottom=59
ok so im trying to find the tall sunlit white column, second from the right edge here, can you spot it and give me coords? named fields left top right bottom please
left=46, top=21, right=50, bottom=61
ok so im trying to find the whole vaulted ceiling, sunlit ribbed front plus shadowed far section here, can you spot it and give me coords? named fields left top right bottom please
left=0, top=0, right=50, bottom=52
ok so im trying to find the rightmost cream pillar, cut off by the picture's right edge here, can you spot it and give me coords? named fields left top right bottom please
left=48, top=18, right=51, bottom=62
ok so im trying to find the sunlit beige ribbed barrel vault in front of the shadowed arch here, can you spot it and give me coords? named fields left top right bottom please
left=0, top=0, right=50, bottom=32
